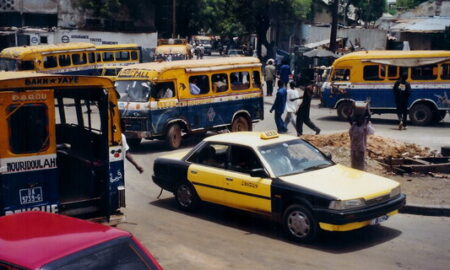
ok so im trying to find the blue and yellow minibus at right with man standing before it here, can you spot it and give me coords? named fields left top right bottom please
left=322, top=51, right=450, bottom=125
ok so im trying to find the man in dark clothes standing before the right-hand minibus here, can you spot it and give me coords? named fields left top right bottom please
left=393, top=73, right=411, bottom=130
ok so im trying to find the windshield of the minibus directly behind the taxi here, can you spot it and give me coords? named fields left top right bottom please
left=115, top=81, right=152, bottom=102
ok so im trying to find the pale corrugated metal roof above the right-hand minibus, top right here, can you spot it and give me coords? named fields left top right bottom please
left=391, top=17, right=450, bottom=33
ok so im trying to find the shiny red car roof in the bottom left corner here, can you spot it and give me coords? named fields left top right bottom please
left=0, top=211, right=131, bottom=269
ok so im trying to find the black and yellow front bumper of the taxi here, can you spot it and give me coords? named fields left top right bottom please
left=314, top=194, right=406, bottom=230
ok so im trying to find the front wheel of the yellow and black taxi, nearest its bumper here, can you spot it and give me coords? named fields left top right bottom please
left=283, top=204, right=319, bottom=243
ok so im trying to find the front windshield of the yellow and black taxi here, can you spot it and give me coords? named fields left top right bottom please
left=258, top=139, right=334, bottom=177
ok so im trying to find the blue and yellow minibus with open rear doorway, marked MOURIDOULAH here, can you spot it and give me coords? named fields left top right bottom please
left=0, top=72, right=125, bottom=218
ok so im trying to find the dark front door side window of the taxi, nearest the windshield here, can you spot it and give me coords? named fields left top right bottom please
left=229, top=145, right=262, bottom=173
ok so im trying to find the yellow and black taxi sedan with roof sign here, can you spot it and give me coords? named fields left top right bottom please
left=153, top=131, right=406, bottom=242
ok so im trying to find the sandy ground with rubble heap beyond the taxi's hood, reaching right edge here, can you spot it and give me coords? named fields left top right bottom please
left=302, top=132, right=450, bottom=205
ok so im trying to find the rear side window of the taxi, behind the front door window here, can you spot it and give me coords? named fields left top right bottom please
left=188, top=144, right=229, bottom=169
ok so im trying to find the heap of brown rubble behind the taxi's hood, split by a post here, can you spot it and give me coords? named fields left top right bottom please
left=302, top=132, right=432, bottom=158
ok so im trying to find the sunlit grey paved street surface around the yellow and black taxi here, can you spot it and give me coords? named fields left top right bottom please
left=119, top=101, right=450, bottom=269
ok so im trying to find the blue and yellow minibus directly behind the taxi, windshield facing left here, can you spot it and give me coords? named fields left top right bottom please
left=115, top=57, right=264, bottom=149
